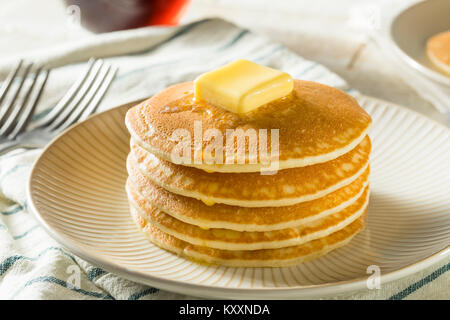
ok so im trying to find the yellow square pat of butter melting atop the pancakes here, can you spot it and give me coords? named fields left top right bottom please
left=194, top=60, right=294, bottom=113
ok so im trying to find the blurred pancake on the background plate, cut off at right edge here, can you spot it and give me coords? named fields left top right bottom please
left=426, top=30, right=450, bottom=75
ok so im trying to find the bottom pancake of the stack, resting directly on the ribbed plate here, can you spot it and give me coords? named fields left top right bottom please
left=130, top=207, right=366, bottom=267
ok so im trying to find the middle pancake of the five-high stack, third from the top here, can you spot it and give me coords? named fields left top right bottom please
left=127, top=156, right=370, bottom=231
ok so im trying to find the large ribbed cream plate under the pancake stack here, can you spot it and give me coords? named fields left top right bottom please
left=28, top=97, right=450, bottom=299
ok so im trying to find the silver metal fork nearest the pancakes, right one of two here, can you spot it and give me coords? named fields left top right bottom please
left=0, top=59, right=117, bottom=155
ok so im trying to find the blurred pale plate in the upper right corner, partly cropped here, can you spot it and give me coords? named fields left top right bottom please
left=390, top=0, right=450, bottom=86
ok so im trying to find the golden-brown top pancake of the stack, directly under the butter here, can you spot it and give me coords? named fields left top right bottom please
left=126, top=80, right=371, bottom=172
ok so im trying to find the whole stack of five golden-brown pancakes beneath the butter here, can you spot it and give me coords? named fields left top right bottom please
left=126, top=80, right=371, bottom=267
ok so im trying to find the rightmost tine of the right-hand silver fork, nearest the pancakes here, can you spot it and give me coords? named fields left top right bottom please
left=58, top=64, right=115, bottom=130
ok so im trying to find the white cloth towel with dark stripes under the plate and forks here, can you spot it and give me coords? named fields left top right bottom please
left=0, top=19, right=449, bottom=299
